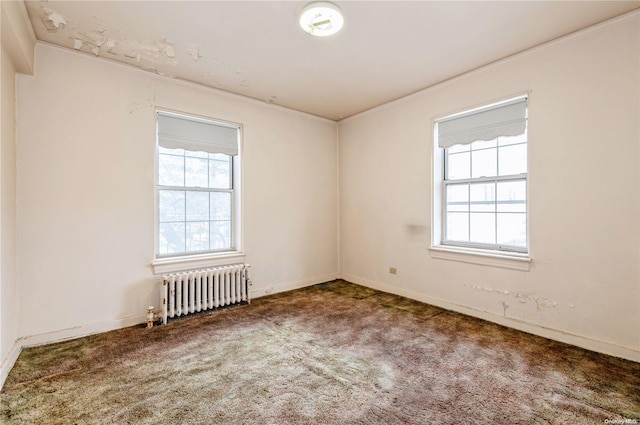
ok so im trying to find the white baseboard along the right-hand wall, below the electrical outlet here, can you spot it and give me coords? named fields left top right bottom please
left=340, top=274, right=640, bottom=362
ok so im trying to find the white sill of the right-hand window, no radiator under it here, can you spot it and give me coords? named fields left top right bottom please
left=429, top=245, right=531, bottom=272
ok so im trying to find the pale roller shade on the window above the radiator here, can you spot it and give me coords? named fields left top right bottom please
left=158, top=113, right=238, bottom=156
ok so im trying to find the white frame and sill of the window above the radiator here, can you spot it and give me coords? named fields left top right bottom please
left=152, top=109, right=245, bottom=274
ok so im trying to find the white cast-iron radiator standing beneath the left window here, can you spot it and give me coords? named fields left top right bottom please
left=161, top=264, right=251, bottom=324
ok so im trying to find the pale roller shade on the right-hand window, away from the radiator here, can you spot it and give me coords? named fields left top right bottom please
left=438, top=98, right=527, bottom=148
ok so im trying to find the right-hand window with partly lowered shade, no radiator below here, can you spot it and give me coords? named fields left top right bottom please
left=434, top=97, right=528, bottom=253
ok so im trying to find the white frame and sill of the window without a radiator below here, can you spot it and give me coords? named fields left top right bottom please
left=429, top=94, right=531, bottom=271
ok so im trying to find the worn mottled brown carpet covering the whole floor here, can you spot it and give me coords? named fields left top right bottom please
left=0, top=281, right=640, bottom=425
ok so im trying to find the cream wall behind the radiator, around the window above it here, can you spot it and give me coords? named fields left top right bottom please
left=17, top=44, right=339, bottom=343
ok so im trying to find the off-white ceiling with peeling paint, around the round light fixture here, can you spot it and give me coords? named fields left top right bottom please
left=25, top=0, right=640, bottom=120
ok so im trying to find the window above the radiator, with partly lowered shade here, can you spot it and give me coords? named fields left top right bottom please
left=156, top=112, right=239, bottom=258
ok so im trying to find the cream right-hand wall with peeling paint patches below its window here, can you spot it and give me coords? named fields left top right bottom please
left=339, top=13, right=640, bottom=360
